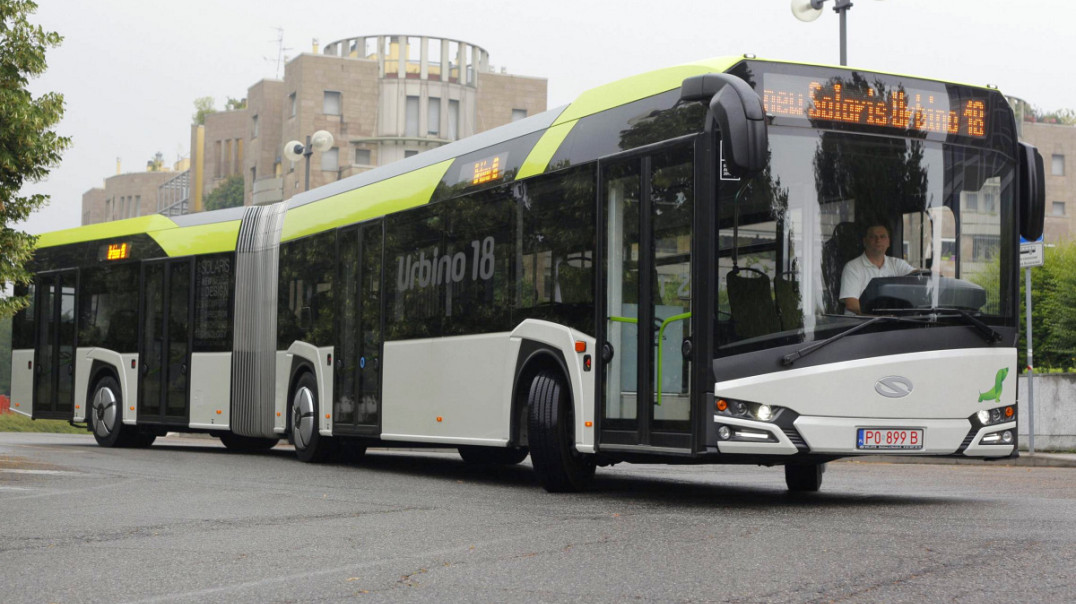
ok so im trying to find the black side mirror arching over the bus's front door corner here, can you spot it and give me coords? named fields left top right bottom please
left=680, top=73, right=769, bottom=177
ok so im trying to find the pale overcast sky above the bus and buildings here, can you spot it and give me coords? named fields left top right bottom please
left=16, top=0, right=1076, bottom=233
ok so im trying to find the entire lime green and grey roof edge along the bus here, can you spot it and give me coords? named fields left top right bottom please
left=38, top=55, right=998, bottom=256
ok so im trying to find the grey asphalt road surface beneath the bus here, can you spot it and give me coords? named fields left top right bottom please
left=0, top=434, right=1076, bottom=603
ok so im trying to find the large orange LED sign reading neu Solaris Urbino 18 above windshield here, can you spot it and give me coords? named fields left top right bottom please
left=763, top=73, right=987, bottom=138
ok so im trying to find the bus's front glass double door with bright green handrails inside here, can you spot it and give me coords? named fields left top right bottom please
left=598, top=144, right=695, bottom=451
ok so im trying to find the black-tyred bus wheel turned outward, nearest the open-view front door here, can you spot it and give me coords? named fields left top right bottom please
left=527, top=371, right=596, bottom=493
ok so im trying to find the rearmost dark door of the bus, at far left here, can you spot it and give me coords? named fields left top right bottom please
left=32, top=270, right=79, bottom=420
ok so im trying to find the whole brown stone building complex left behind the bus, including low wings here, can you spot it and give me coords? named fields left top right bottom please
left=83, top=34, right=547, bottom=224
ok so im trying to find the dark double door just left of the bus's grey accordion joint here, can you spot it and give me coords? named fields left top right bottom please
left=138, top=258, right=194, bottom=425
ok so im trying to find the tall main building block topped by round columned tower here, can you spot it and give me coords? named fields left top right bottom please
left=243, top=36, right=547, bottom=205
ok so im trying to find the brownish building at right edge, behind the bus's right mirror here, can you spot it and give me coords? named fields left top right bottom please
left=1020, top=122, right=1076, bottom=243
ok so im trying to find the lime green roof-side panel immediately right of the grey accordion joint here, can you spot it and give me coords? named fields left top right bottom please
left=280, top=158, right=455, bottom=241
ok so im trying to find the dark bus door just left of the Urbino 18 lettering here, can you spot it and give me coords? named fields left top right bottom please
left=332, top=221, right=382, bottom=436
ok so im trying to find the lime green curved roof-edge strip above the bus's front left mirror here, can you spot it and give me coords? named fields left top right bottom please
left=551, top=57, right=744, bottom=126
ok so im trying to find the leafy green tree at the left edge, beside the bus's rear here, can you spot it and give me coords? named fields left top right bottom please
left=0, top=0, right=71, bottom=317
